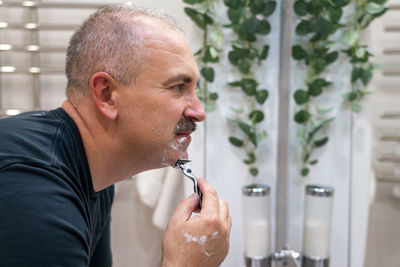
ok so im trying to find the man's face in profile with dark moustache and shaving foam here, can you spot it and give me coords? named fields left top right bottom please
left=115, top=19, right=205, bottom=168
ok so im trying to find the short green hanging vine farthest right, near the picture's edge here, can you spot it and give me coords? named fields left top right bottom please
left=342, top=0, right=387, bottom=112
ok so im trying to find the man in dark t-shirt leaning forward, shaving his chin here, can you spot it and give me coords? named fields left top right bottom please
left=0, top=6, right=231, bottom=267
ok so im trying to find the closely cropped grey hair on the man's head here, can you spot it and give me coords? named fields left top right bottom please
left=65, top=5, right=179, bottom=98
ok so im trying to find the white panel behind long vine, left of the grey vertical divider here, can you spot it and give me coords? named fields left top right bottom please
left=206, top=1, right=281, bottom=267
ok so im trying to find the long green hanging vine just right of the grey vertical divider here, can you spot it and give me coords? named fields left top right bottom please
left=292, top=0, right=350, bottom=176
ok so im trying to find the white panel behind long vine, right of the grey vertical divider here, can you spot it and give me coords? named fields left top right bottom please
left=288, top=7, right=352, bottom=267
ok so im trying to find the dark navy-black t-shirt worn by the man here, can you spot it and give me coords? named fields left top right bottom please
left=0, top=108, right=114, bottom=267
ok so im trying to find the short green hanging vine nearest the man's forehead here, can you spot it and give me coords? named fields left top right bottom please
left=183, top=0, right=223, bottom=111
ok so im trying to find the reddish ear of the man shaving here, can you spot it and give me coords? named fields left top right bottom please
left=90, top=72, right=118, bottom=120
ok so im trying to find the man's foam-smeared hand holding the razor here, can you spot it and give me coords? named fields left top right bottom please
left=161, top=178, right=232, bottom=267
